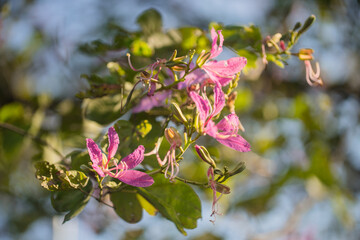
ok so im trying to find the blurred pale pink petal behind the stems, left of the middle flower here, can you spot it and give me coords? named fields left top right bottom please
left=133, top=91, right=172, bottom=113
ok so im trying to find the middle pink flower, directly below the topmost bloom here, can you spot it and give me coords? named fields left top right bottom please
left=189, top=84, right=250, bottom=152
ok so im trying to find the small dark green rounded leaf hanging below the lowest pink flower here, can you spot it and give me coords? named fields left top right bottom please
left=110, top=192, right=142, bottom=223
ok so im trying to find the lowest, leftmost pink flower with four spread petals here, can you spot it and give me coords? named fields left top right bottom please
left=86, top=127, right=154, bottom=187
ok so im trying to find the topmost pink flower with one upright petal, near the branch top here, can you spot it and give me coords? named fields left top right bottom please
left=201, top=28, right=247, bottom=86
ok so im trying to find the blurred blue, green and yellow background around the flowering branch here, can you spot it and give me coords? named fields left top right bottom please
left=0, top=0, right=360, bottom=240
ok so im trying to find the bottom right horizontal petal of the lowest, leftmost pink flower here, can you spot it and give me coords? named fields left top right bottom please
left=117, top=170, right=154, bottom=187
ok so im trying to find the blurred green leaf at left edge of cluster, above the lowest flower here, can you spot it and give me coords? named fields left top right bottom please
left=83, top=94, right=122, bottom=125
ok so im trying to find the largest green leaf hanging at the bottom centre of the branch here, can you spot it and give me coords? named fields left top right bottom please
left=138, top=175, right=201, bottom=235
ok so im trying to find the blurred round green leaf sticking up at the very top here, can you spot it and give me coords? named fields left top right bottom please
left=136, top=8, right=162, bottom=36
